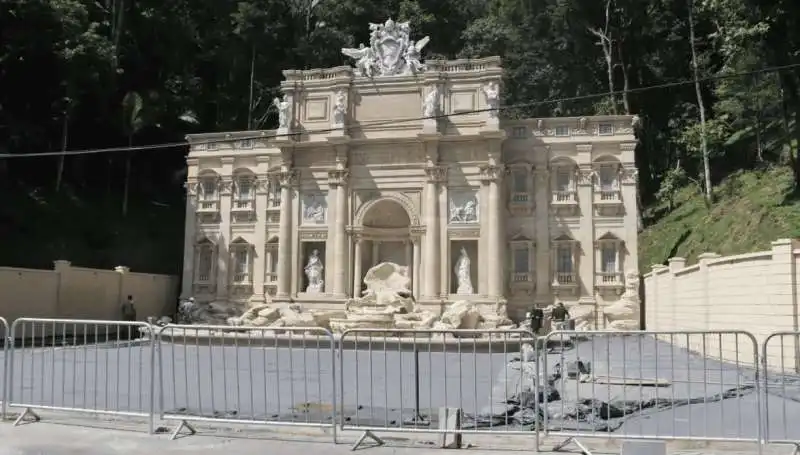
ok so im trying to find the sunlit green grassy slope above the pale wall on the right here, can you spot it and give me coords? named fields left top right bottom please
left=639, top=167, right=800, bottom=273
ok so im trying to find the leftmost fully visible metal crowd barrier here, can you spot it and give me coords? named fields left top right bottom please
left=7, top=318, right=154, bottom=433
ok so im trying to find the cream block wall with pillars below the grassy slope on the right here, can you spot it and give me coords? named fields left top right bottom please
left=644, top=239, right=800, bottom=370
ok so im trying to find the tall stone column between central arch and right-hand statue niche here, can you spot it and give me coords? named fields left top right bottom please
left=422, top=166, right=447, bottom=300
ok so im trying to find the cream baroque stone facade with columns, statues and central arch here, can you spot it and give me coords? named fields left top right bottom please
left=182, top=21, right=638, bottom=327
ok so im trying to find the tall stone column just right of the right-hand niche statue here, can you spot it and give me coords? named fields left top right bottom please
left=483, top=165, right=506, bottom=298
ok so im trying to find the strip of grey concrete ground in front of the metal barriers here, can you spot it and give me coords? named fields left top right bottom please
left=0, top=413, right=780, bottom=455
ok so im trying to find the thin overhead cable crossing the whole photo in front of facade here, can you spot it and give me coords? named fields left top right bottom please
left=0, top=63, right=800, bottom=159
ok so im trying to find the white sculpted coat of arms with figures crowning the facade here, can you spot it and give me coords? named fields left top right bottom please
left=342, top=19, right=430, bottom=78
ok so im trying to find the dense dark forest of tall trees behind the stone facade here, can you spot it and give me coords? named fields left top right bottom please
left=0, top=0, right=800, bottom=272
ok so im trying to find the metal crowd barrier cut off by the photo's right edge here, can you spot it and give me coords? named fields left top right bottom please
left=761, top=332, right=800, bottom=448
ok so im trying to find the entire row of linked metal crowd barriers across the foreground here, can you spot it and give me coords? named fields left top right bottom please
left=0, top=317, right=800, bottom=453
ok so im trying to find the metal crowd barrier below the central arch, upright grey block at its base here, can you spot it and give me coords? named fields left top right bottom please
left=339, top=329, right=539, bottom=449
